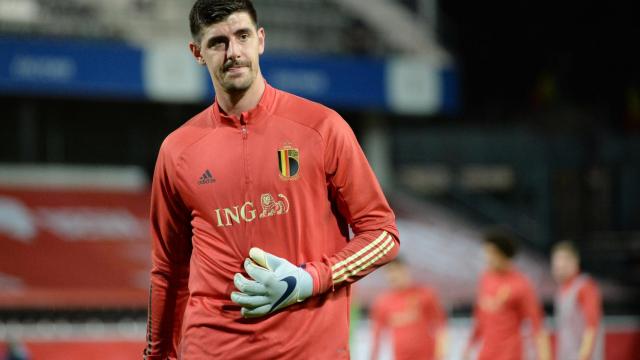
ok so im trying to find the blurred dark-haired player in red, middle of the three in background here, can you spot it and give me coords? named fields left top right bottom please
left=465, top=231, right=550, bottom=360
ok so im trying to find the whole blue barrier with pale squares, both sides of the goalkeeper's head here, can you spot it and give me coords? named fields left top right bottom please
left=0, top=37, right=458, bottom=114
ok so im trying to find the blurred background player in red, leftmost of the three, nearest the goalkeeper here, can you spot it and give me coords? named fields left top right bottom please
left=371, top=258, right=446, bottom=360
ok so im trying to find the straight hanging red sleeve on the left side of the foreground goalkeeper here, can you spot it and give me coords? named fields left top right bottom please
left=144, top=142, right=191, bottom=360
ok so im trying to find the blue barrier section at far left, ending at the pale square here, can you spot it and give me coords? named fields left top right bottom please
left=0, top=38, right=145, bottom=98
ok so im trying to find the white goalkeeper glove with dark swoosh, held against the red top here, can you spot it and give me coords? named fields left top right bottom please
left=231, top=248, right=313, bottom=318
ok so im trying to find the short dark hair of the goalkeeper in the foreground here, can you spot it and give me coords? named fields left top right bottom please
left=189, top=0, right=258, bottom=41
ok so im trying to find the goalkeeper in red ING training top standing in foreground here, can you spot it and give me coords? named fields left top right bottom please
left=145, top=0, right=399, bottom=360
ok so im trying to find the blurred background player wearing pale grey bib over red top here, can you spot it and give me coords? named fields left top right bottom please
left=551, top=241, right=604, bottom=360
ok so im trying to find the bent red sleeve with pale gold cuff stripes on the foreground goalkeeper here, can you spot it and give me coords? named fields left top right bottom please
left=307, top=114, right=399, bottom=294
